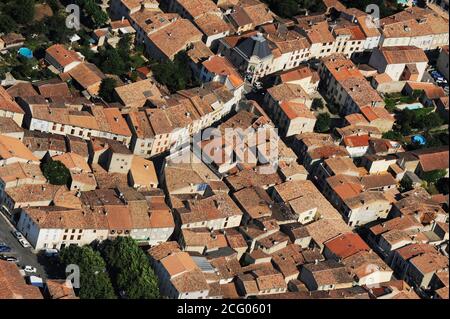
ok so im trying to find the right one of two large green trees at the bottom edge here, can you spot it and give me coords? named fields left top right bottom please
left=101, top=237, right=159, bottom=299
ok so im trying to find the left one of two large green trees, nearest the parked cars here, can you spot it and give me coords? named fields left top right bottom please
left=59, top=246, right=116, bottom=299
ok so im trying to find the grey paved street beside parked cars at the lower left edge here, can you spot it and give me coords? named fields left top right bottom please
left=0, top=212, right=46, bottom=278
